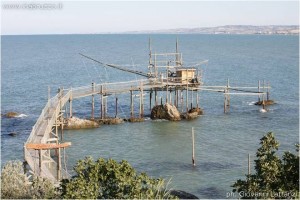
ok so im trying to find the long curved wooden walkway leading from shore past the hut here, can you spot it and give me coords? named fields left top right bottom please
left=24, top=77, right=269, bottom=182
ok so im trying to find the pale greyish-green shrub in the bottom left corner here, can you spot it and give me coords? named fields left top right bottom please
left=1, top=161, right=60, bottom=199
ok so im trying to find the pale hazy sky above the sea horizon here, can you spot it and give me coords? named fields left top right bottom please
left=1, top=1, right=299, bottom=35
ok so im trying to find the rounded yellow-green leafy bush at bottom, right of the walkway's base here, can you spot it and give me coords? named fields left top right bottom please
left=61, top=157, right=174, bottom=199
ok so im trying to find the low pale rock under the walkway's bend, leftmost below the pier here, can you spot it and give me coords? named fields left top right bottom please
left=64, top=117, right=99, bottom=129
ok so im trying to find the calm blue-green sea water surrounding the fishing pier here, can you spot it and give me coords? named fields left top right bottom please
left=1, top=35, right=299, bottom=198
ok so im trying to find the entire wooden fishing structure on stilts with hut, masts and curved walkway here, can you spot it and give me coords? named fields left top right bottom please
left=24, top=40, right=270, bottom=182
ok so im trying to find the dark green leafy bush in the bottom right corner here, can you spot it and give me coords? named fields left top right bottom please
left=232, top=132, right=299, bottom=199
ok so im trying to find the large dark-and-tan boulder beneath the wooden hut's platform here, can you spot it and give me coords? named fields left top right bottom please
left=151, top=103, right=181, bottom=121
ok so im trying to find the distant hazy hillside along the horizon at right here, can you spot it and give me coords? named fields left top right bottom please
left=126, top=25, right=299, bottom=35
